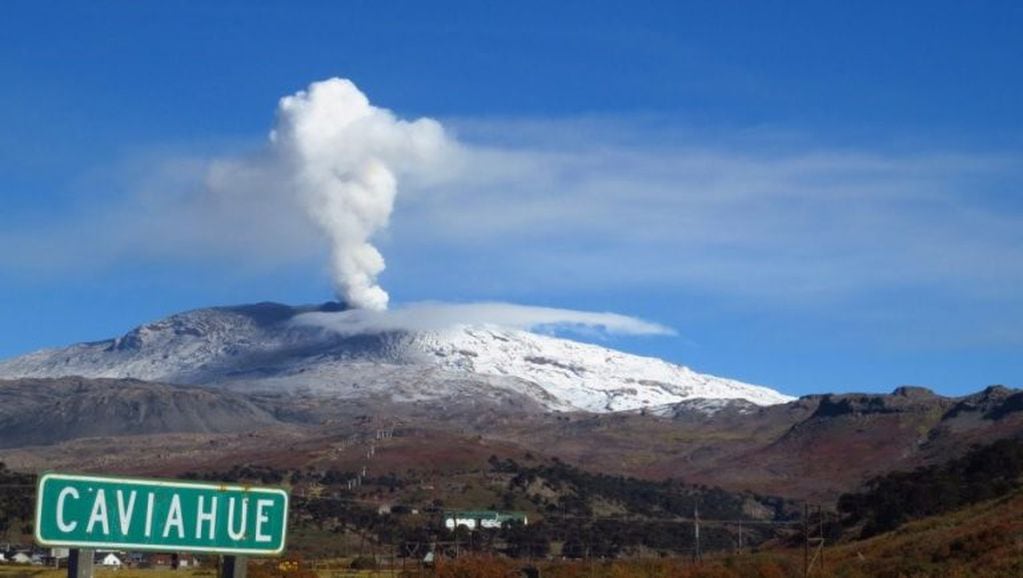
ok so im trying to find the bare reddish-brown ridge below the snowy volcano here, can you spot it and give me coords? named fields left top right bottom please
left=0, top=379, right=1023, bottom=500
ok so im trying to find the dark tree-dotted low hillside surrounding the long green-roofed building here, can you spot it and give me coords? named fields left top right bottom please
left=180, top=456, right=789, bottom=559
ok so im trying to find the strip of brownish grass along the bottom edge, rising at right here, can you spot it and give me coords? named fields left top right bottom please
left=0, top=491, right=1023, bottom=578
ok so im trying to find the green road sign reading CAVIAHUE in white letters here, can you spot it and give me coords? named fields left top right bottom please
left=36, top=474, right=287, bottom=555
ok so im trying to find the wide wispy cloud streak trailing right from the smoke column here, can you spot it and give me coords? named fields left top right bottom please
left=393, top=123, right=1023, bottom=301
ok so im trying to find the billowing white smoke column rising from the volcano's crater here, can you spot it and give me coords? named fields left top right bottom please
left=270, top=78, right=451, bottom=311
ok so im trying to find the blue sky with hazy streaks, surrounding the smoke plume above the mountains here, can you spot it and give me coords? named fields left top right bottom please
left=0, top=1, right=1023, bottom=394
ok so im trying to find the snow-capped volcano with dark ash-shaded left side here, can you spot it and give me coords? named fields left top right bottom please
left=0, top=303, right=792, bottom=412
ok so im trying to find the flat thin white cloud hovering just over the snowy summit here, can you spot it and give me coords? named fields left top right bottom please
left=295, top=303, right=674, bottom=336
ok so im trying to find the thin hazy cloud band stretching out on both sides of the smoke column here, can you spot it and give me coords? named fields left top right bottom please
left=0, top=91, right=1023, bottom=315
